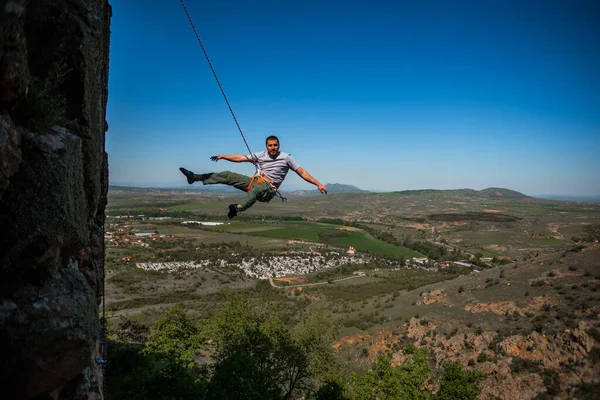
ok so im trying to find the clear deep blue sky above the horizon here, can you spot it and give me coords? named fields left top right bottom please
left=106, top=0, right=600, bottom=195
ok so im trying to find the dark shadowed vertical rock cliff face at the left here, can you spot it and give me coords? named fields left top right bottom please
left=0, top=0, right=111, bottom=399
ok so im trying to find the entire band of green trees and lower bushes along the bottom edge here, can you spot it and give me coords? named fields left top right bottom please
left=105, top=292, right=481, bottom=400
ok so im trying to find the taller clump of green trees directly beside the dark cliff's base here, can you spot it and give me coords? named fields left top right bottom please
left=106, top=292, right=337, bottom=400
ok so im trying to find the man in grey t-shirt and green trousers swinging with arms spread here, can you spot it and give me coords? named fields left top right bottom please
left=179, top=136, right=327, bottom=218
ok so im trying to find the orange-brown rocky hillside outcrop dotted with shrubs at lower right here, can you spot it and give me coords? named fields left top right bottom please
left=334, top=312, right=600, bottom=400
